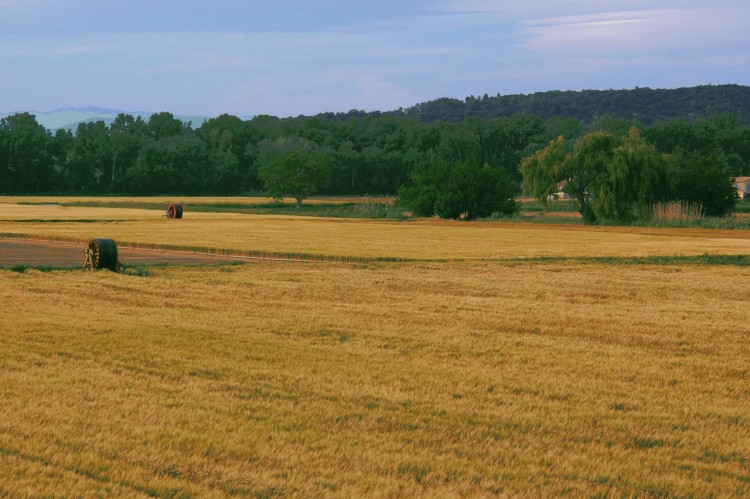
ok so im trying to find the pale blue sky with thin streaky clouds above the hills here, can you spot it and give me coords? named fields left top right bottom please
left=0, top=0, right=750, bottom=117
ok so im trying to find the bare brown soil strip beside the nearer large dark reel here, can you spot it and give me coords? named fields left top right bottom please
left=0, top=238, right=256, bottom=268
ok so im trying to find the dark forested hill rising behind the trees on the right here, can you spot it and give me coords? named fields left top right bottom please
left=384, top=85, right=750, bottom=125
